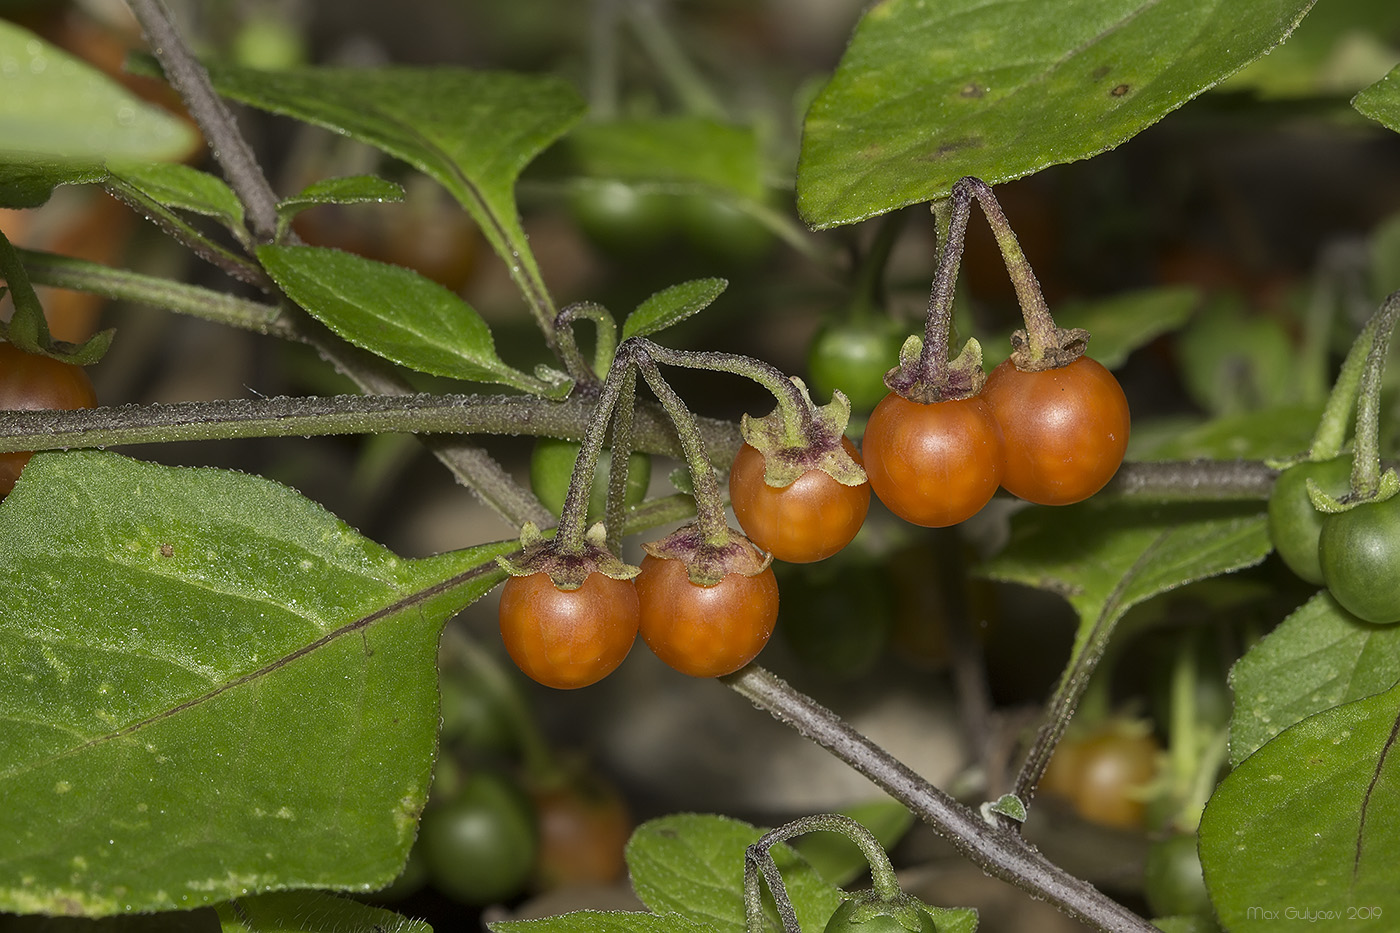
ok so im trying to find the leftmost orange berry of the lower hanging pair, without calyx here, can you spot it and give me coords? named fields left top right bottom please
left=500, top=573, right=638, bottom=689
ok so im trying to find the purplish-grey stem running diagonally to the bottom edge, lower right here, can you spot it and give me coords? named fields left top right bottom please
left=720, top=664, right=1156, bottom=933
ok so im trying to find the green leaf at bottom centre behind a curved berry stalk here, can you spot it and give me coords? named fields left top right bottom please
left=627, top=814, right=841, bottom=933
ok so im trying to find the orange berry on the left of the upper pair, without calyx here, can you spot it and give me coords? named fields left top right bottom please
left=861, top=392, right=1005, bottom=528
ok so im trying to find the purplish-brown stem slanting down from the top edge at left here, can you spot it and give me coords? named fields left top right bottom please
left=127, top=0, right=277, bottom=242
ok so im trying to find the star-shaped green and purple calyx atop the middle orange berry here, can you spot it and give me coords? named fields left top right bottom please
left=739, top=377, right=865, bottom=489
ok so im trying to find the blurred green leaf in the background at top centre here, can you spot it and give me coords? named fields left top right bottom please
left=561, top=116, right=763, bottom=200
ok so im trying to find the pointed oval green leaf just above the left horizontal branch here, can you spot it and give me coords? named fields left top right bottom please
left=258, top=245, right=557, bottom=394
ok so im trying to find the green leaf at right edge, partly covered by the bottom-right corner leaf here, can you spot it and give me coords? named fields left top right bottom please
left=1229, top=590, right=1400, bottom=765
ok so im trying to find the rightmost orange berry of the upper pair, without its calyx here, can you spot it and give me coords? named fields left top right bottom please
left=981, top=356, right=1128, bottom=506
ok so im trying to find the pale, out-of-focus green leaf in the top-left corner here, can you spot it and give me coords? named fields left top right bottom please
left=0, top=20, right=199, bottom=167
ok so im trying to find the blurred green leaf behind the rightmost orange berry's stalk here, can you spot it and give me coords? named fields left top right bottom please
left=981, top=287, right=1200, bottom=370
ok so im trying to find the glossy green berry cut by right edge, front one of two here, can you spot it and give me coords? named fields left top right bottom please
left=1317, top=496, right=1400, bottom=625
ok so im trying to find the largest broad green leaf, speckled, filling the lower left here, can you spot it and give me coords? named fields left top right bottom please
left=0, top=451, right=514, bottom=916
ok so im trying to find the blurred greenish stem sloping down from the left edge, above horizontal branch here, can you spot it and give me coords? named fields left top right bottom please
left=17, top=249, right=305, bottom=340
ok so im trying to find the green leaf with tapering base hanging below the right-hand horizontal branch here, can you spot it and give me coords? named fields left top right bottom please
left=980, top=502, right=1274, bottom=700
